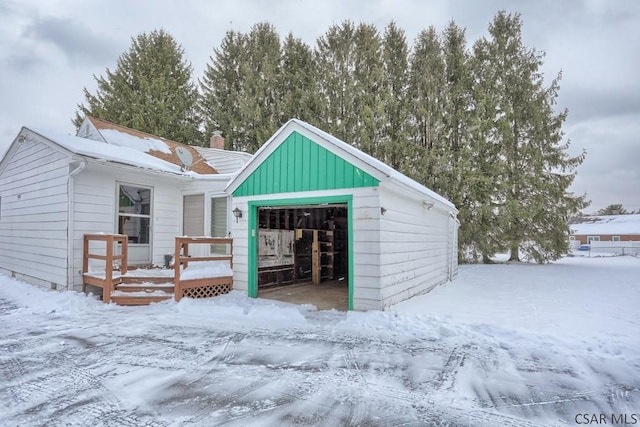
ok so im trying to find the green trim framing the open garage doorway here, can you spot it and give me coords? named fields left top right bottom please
left=247, top=194, right=354, bottom=310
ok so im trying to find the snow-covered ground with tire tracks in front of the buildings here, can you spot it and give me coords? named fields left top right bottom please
left=0, top=257, right=640, bottom=426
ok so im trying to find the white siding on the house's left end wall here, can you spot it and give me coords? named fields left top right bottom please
left=0, top=138, right=69, bottom=289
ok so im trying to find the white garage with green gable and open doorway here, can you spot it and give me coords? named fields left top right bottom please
left=226, top=120, right=458, bottom=310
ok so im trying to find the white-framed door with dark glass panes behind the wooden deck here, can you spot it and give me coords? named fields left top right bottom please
left=118, top=184, right=153, bottom=264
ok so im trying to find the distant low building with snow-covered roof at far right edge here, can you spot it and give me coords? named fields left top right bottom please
left=569, top=214, right=640, bottom=245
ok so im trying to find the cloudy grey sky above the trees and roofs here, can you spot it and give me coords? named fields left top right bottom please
left=0, top=0, right=640, bottom=211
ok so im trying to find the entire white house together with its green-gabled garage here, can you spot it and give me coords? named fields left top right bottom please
left=0, top=118, right=458, bottom=310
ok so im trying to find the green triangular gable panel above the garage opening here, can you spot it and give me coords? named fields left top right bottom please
left=233, top=132, right=380, bottom=197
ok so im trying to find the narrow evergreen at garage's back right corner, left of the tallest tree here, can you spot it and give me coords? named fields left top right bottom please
left=434, top=22, right=497, bottom=260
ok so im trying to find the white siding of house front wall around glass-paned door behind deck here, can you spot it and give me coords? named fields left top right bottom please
left=71, top=164, right=182, bottom=290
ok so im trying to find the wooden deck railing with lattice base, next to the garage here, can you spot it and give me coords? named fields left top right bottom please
left=173, top=237, right=233, bottom=301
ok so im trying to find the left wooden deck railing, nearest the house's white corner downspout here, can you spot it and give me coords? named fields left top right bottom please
left=82, top=234, right=129, bottom=303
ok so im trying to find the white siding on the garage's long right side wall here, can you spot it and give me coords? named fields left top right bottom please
left=380, top=186, right=451, bottom=308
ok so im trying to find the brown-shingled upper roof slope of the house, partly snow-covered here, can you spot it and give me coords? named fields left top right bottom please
left=85, top=116, right=218, bottom=175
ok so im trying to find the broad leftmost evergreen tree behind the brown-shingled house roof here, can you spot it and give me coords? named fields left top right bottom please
left=73, top=30, right=203, bottom=144
